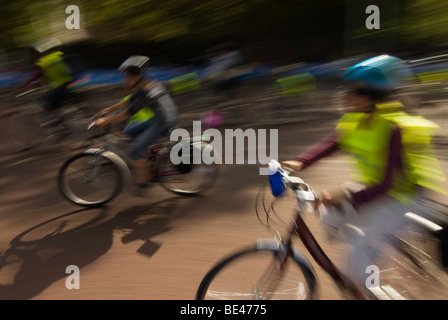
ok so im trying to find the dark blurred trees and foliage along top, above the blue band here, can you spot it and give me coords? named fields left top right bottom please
left=0, top=0, right=448, bottom=78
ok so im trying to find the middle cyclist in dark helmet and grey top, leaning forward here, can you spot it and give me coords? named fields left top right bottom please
left=95, top=56, right=177, bottom=195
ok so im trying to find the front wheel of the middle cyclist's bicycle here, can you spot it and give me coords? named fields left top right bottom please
left=58, top=152, right=124, bottom=208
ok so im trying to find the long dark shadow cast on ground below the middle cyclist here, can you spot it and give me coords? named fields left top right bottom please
left=0, top=197, right=180, bottom=300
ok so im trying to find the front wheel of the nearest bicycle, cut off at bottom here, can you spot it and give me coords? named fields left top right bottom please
left=196, top=247, right=316, bottom=300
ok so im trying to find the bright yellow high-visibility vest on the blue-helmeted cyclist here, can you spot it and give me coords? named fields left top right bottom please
left=336, top=103, right=448, bottom=203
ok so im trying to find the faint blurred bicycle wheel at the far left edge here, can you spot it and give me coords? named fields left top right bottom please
left=0, top=112, right=44, bottom=154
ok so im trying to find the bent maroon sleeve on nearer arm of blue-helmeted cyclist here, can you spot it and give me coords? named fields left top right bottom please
left=351, top=126, right=403, bottom=204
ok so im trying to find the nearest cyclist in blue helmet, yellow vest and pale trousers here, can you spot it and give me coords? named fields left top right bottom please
left=282, top=55, right=447, bottom=285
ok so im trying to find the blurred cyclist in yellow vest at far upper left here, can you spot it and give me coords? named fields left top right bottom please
left=11, top=38, right=73, bottom=111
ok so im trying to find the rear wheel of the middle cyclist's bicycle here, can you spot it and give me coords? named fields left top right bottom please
left=159, top=142, right=219, bottom=196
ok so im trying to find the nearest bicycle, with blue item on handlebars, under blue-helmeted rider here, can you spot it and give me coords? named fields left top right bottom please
left=196, top=160, right=446, bottom=300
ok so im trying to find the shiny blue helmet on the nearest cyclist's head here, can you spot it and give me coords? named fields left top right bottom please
left=343, top=54, right=412, bottom=90
